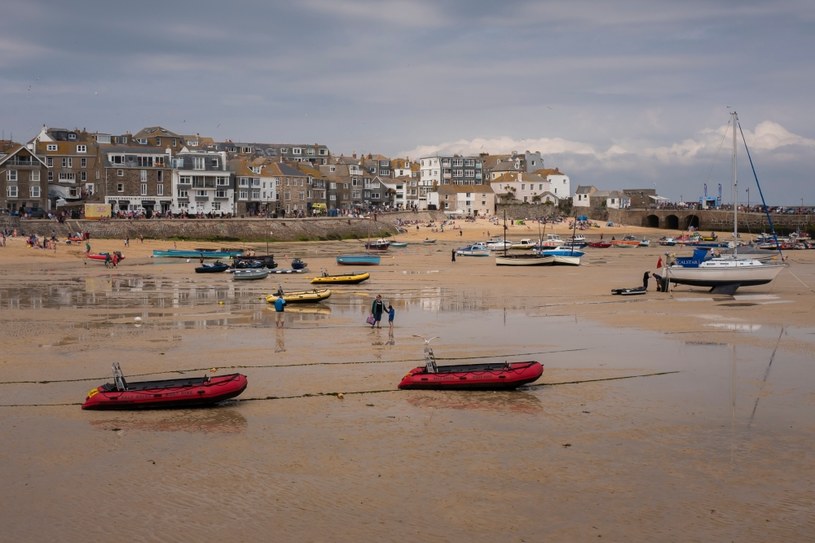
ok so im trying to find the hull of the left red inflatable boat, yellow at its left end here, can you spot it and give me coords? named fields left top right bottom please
left=82, top=373, right=247, bottom=410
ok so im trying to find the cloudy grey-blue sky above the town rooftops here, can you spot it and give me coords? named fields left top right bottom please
left=0, top=0, right=815, bottom=206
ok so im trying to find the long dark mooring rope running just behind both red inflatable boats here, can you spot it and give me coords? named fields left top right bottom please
left=0, top=348, right=587, bottom=385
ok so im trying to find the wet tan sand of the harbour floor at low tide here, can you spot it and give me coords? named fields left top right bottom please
left=0, top=222, right=815, bottom=542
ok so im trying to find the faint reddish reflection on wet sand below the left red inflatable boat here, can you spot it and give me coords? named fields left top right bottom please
left=90, top=401, right=246, bottom=433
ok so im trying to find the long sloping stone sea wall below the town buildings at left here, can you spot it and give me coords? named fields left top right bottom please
left=0, top=212, right=444, bottom=242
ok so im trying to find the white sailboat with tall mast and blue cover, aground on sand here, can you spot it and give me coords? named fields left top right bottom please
left=657, top=111, right=786, bottom=294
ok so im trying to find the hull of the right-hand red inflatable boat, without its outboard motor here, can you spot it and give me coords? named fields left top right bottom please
left=399, top=361, right=543, bottom=390
